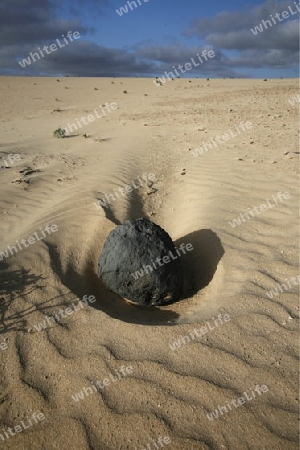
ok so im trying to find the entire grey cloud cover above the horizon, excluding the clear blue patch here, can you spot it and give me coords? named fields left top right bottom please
left=0, top=0, right=299, bottom=77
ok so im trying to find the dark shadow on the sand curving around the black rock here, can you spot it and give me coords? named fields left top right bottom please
left=46, top=230, right=224, bottom=325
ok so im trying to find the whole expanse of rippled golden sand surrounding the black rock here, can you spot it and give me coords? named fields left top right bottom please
left=0, top=77, right=299, bottom=450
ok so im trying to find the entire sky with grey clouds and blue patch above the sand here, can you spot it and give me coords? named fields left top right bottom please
left=0, top=0, right=300, bottom=78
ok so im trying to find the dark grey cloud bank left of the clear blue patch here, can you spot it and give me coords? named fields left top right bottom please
left=0, top=0, right=153, bottom=76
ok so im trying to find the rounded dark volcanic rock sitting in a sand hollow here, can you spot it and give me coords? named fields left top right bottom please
left=98, top=219, right=183, bottom=306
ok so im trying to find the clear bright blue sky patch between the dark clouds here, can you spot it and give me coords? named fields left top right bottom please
left=91, top=0, right=261, bottom=47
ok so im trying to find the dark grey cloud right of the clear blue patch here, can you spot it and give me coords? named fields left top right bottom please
left=183, top=0, right=299, bottom=73
